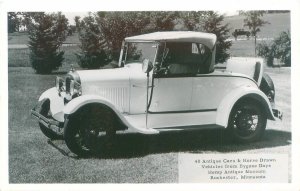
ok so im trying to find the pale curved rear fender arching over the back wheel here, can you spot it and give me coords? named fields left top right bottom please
left=216, top=86, right=275, bottom=127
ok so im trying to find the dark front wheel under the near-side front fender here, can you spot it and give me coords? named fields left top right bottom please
left=64, top=105, right=116, bottom=156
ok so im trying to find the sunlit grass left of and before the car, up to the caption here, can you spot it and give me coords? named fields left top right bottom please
left=9, top=67, right=177, bottom=183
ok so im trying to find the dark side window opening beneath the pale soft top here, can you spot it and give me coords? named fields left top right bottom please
left=158, top=42, right=211, bottom=76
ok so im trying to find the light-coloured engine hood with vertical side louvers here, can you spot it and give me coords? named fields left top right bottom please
left=77, top=64, right=145, bottom=112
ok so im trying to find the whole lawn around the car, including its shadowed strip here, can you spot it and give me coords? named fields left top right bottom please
left=8, top=67, right=291, bottom=183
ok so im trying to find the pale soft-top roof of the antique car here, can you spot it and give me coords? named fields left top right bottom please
left=125, top=31, right=217, bottom=49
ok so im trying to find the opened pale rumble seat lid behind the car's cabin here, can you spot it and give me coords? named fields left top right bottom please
left=226, top=58, right=263, bottom=84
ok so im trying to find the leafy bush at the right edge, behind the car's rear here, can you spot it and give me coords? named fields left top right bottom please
left=257, top=32, right=291, bottom=66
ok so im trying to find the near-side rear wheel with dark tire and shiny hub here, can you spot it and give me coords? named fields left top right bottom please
left=228, top=100, right=267, bottom=143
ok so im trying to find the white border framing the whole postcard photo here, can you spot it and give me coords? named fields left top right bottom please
left=0, top=0, right=300, bottom=191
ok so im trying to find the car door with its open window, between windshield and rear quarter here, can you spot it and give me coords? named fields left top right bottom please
left=149, top=42, right=194, bottom=113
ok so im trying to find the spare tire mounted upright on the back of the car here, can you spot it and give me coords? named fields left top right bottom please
left=259, top=73, right=275, bottom=102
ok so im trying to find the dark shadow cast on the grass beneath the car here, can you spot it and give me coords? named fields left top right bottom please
left=49, top=129, right=291, bottom=159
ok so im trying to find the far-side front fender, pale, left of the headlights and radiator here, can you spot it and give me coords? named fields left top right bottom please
left=39, top=87, right=64, bottom=122
